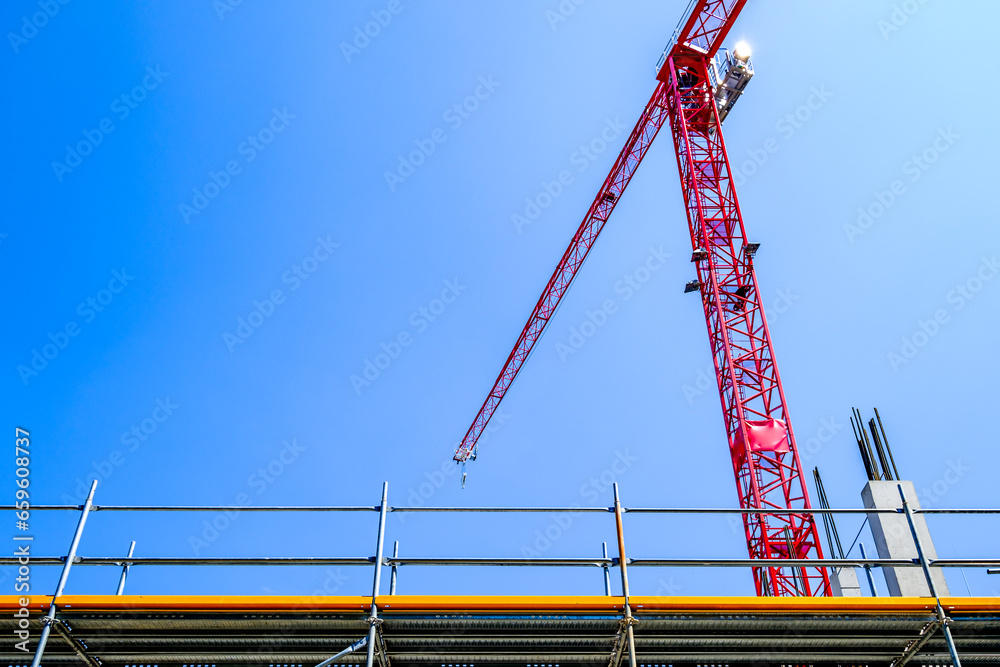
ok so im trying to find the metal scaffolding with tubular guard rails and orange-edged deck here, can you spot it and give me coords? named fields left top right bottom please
left=7, top=482, right=1000, bottom=667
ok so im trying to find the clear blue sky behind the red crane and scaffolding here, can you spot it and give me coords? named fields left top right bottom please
left=0, top=0, right=1000, bottom=594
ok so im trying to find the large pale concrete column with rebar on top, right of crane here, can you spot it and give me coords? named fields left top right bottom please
left=861, top=481, right=948, bottom=597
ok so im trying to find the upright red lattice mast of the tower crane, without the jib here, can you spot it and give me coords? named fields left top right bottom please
left=660, top=52, right=830, bottom=596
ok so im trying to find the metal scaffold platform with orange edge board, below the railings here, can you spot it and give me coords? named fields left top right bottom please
left=0, top=595, right=1000, bottom=667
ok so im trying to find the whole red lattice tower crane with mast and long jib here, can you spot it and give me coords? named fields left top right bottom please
left=455, top=0, right=830, bottom=596
